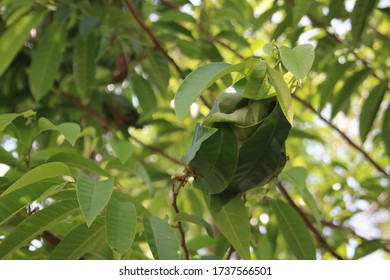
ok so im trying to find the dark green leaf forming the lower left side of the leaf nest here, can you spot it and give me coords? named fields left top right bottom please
left=188, top=124, right=238, bottom=194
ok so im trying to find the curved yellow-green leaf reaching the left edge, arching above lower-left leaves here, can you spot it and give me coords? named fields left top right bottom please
left=0, top=162, right=70, bottom=197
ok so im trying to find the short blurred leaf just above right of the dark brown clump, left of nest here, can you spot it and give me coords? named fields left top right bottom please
left=131, top=75, right=157, bottom=113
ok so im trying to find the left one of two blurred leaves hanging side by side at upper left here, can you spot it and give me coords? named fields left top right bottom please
left=28, top=22, right=66, bottom=101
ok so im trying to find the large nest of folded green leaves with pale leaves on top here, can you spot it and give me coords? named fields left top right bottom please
left=175, top=44, right=314, bottom=207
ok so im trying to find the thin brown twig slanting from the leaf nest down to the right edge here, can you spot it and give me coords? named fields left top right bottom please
left=292, top=94, right=388, bottom=176
